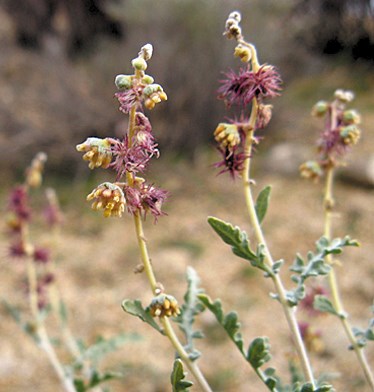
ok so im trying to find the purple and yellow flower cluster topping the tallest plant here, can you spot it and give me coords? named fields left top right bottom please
left=214, top=11, right=282, bottom=178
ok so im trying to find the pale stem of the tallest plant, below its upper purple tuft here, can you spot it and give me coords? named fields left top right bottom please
left=242, top=99, right=315, bottom=388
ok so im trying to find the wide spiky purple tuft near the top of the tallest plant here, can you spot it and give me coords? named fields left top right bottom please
left=218, top=65, right=282, bottom=107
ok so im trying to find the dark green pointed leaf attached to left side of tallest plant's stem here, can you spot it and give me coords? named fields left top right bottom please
left=208, top=217, right=273, bottom=275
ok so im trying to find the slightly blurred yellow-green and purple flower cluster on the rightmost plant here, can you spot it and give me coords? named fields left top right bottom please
left=299, top=89, right=361, bottom=179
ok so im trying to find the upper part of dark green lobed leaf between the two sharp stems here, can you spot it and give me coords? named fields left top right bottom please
left=198, top=294, right=245, bottom=356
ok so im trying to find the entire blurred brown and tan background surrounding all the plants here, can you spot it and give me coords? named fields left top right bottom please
left=0, top=0, right=374, bottom=392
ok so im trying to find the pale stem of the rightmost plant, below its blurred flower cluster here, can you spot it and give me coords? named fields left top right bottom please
left=324, top=166, right=374, bottom=391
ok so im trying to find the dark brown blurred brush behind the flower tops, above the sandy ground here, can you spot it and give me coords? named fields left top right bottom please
left=0, top=0, right=374, bottom=179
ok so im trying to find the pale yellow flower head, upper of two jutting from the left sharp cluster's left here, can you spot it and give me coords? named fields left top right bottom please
left=76, top=137, right=112, bottom=169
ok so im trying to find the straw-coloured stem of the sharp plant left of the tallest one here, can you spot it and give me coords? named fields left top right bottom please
left=127, top=107, right=212, bottom=392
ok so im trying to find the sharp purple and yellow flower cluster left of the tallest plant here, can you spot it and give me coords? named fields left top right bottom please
left=76, top=44, right=167, bottom=219
